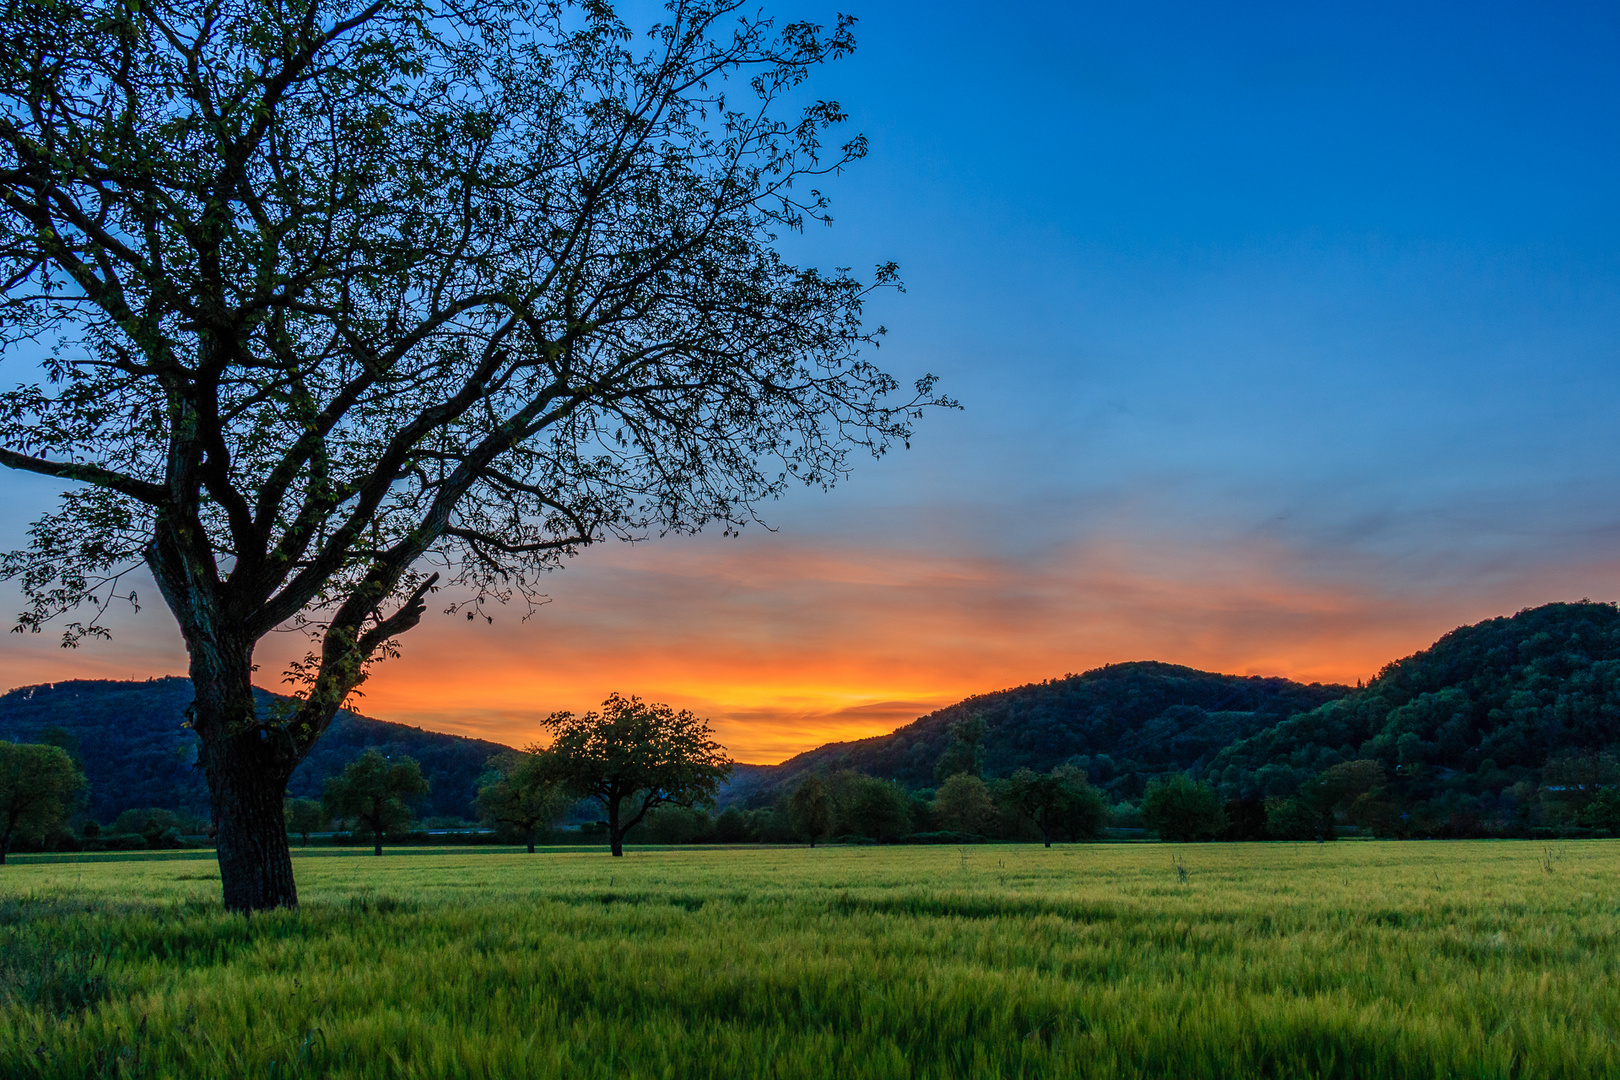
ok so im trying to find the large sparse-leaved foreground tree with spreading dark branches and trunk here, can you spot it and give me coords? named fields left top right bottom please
left=0, top=0, right=940, bottom=910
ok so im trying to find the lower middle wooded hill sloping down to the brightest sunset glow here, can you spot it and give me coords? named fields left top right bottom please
left=727, top=661, right=1349, bottom=805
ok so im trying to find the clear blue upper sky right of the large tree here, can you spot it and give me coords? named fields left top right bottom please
left=767, top=3, right=1620, bottom=563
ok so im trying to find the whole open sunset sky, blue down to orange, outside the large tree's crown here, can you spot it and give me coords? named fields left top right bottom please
left=0, top=0, right=1620, bottom=761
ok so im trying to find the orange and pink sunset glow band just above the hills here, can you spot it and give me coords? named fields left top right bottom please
left=0, top=534, right=1620, bottom=763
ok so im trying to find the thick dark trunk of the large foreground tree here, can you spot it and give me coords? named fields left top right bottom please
left=188, top=640, right=300, bottom=913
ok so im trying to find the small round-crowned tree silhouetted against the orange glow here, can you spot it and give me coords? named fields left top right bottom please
left=543, top=695, right=731, bottom=855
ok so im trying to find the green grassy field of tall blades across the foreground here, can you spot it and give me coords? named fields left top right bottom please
left=0, top=840, right=1620, bottom=1080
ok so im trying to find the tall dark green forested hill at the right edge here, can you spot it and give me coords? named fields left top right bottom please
left=1209, top=601, right=1620, bottom=803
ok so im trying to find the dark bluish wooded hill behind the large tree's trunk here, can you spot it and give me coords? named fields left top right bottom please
left=0, top=678, right=507, bottom=821
